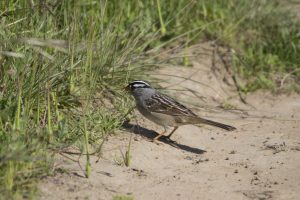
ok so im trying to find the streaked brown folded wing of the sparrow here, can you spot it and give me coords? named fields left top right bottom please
left=145, top=93, right=197, bottom=117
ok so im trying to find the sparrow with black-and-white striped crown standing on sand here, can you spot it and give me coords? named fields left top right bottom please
left=126, top=80, right=236, bottom=140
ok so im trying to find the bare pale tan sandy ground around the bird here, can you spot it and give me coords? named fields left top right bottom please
left=40, top=44, right=300, bottom=200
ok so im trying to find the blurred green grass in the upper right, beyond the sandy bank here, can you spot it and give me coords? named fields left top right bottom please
left=186, top=0, right=300, bottom=92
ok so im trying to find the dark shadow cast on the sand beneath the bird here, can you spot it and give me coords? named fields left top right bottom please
left=122, top=122, right=206, bottom=154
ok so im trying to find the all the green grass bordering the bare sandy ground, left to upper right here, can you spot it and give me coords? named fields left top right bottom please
left=0, top=0, right=300, bottom=199
